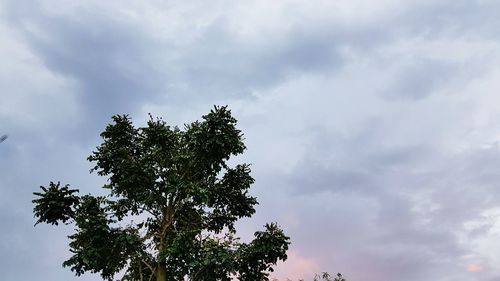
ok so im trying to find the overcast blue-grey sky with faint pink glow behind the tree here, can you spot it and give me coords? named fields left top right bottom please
left=0, top=0, right=500, bottom=281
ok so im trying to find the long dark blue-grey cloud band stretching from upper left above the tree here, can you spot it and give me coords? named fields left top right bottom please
left=4, top=1, right=343, bottom=115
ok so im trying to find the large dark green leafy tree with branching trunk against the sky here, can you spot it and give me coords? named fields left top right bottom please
left=33, top=106, right=290, bottom=281
